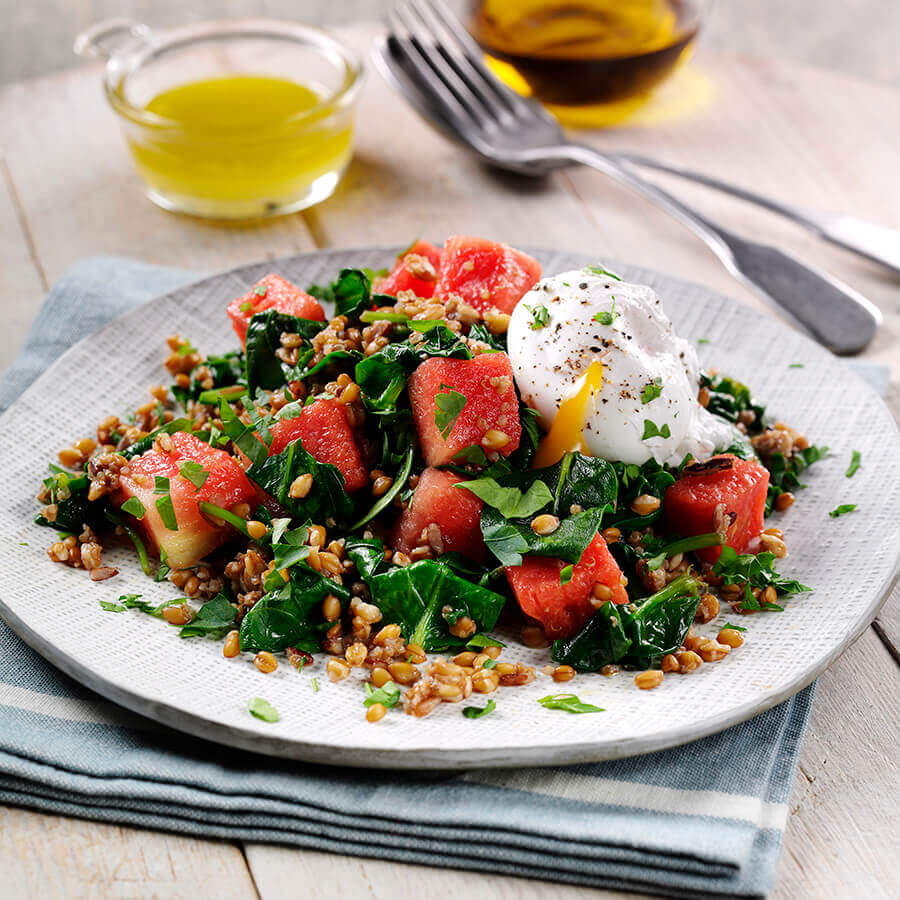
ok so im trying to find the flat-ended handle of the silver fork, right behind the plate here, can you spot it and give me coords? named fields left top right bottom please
left=556, top=143, right=881, bottom=353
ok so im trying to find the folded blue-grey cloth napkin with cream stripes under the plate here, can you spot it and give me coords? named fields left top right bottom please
left=0, top=257, right=840, bottom=897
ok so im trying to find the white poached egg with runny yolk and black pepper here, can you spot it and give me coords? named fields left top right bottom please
left=507, top=266, right=739, bottom=466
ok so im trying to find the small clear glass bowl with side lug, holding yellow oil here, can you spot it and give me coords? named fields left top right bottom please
left=75, top=19, right=362, bottom=219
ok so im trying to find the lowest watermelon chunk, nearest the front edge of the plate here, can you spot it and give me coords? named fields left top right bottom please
left=506, top=534, right=628, bottom=639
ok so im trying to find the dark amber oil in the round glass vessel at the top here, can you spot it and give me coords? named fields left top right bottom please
left=468, top=0, right=697, bottom=107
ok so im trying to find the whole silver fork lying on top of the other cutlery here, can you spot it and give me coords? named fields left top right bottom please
left=375, top=0, right=881, bottom=353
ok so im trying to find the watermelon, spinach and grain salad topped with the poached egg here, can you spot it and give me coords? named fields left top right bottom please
left=36, top=236, right=825, bottom=722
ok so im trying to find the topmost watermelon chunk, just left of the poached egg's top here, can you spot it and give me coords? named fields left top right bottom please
left=434, top=236, right=541, bottom=313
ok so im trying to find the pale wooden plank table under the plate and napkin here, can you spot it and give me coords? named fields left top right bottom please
left=0, top=22, right=900, bottom=900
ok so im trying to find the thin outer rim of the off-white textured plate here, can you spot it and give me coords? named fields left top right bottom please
left=0, top=244, right=900, bottom=771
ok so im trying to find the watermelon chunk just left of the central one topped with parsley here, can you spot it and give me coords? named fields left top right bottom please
left=269, top=400, right=369, bottom=492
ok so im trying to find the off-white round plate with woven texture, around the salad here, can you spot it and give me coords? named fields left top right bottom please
left=0, top=248, right=900, bottom=769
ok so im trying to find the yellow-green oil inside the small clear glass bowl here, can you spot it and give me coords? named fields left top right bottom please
left=129, top=75, right=352, bottom=218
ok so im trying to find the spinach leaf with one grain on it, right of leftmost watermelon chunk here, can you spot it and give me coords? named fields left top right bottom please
left=247, top=438, right=353, bottom=523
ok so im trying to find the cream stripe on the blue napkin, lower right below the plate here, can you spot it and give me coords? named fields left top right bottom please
left=462, top=768, right=788, bottom=830
